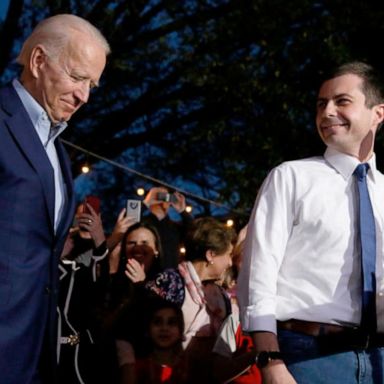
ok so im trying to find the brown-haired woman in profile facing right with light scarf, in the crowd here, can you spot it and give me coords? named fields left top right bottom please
left=146, top=217, right=236, bottom=384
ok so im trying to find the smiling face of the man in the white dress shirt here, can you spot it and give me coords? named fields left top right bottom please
left=316, top=74, right=383, bottom=161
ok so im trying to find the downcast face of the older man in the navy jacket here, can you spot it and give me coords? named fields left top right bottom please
left=31, top=33, right=106, bottom=123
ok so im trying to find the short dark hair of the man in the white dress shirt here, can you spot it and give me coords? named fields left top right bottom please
left=324, top=61, right=384, bottom=108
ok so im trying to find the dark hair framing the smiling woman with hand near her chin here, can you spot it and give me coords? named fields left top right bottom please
left=119, top=222, right=163, bottom=279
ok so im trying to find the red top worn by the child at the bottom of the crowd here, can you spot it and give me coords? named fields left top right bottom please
left=136, top=357, right=187, bottom=384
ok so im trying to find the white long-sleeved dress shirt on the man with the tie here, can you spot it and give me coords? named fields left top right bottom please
left=238, top=148, right=384, bottom=333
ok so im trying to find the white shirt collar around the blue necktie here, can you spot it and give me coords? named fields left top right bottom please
left=324, top=147, right=376, bottom=181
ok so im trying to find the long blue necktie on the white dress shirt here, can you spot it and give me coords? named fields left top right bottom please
left=354, top=163, right=377, bottom=334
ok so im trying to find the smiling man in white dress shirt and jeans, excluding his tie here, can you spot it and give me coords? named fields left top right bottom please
left=238, top=62, right=384, bottom=384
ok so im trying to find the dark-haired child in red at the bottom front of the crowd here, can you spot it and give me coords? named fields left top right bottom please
left=118, top=299, right=188, bottom=384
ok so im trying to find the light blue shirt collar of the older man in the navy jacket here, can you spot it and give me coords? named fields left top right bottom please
left=12, top=79, right=67, bottom=145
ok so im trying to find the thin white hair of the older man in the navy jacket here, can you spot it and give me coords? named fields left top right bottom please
left=17, top=14, right=111, bottom=66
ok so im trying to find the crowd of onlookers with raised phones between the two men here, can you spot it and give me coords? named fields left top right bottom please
left=54, top=187, right=260, bottom=384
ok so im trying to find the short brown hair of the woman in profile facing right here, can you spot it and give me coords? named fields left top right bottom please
left=185, top=217, right=236, bottom=261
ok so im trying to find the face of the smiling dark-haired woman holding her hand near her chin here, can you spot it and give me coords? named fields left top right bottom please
left=125, top=228, right=158, bottom=272
